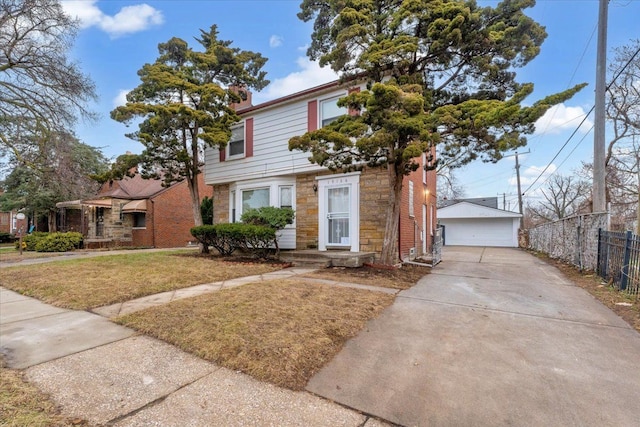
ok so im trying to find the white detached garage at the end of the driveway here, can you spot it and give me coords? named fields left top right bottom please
left=438, top=201, right=521, bottom=248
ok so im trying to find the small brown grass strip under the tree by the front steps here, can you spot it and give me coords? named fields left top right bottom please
left=304, top=265, right=431, bottom=289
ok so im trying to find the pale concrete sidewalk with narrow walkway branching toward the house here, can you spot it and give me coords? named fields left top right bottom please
left=0, top=269, right=388, bottom=427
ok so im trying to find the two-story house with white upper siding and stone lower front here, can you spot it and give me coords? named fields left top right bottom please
left=204, top=82, right=437, bottom=260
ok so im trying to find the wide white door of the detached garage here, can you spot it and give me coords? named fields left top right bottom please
left=440, top=218, right=517, bottom=247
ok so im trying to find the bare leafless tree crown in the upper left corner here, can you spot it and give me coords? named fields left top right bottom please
left=0, top=0, right=96, bottom=161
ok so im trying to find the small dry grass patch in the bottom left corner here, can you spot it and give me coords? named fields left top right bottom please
left=0, top=367, right=88, bottom=427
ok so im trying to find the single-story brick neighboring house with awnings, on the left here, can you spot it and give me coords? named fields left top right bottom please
left=56, top=174, right=212, bottom=248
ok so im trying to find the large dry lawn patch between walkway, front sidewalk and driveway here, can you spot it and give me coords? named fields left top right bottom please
left=116, top=278, right=394, bottom=390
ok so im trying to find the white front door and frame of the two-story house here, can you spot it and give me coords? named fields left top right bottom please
left=318, top=174, right=360, bottom=252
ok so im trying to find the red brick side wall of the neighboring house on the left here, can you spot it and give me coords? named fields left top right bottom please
left=149, top=174, right=213, bottom=248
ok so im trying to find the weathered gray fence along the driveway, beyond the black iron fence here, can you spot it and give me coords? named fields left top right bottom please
left=528, top=213, right=609, bottom=270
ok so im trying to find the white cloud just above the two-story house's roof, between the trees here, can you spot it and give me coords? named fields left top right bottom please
left=253, top=57, right=338, bottom=103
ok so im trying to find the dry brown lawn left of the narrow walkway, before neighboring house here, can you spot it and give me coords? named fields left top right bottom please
left=2, top=251, right=285, bottom=310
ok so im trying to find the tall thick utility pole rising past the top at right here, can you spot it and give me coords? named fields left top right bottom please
left=592, top=0, right=609, bottom=212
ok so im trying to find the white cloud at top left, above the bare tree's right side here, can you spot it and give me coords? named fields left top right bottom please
left=62, top=0, right=164, bottom=37
